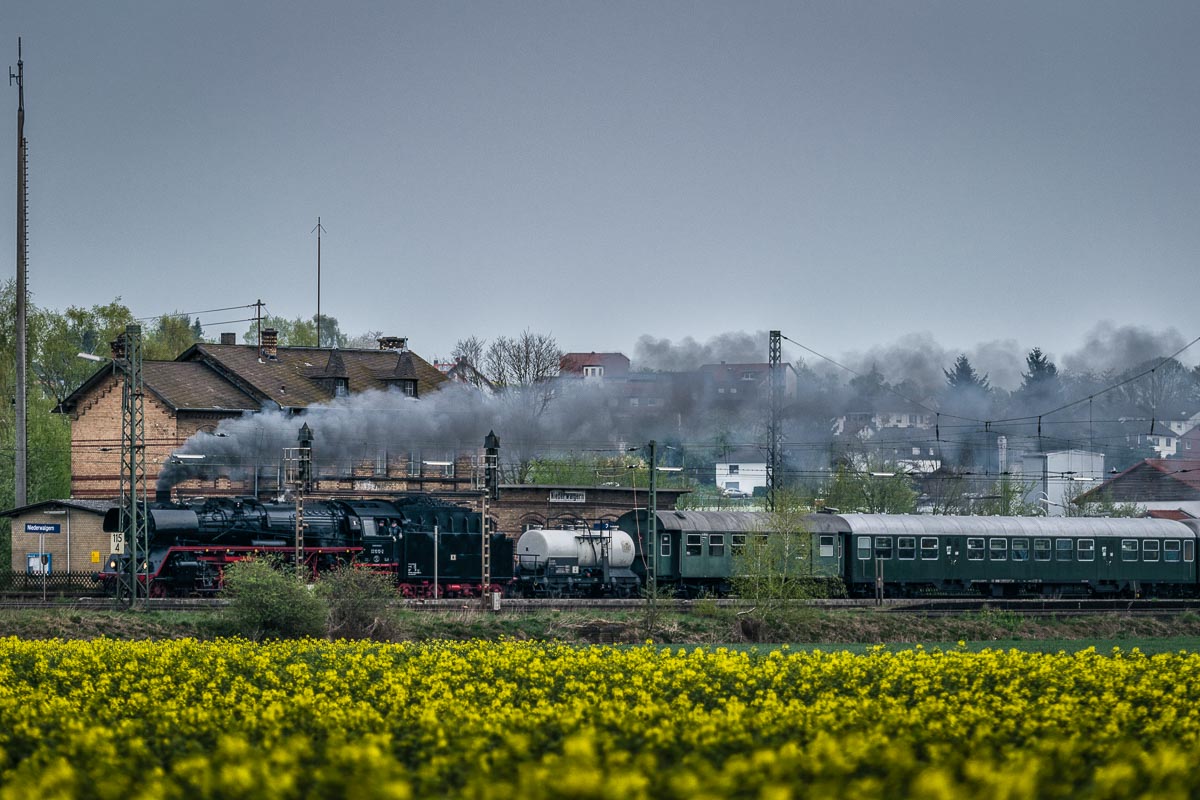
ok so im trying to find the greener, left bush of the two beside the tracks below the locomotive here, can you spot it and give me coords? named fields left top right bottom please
left=224, top=559, right=328, bottom=642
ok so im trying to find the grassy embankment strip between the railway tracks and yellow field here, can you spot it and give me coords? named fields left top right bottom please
left=0, top=607, right=1200, bottom=651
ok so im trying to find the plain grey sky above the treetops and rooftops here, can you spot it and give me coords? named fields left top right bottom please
left=0, top=0, right=1200, bottom=376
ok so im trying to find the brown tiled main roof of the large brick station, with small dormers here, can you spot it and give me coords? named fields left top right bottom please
left=179, top=343, right=446, bottom=408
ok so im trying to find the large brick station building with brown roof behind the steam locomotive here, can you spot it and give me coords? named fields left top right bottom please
left=58, top=329, right=451, bottom=499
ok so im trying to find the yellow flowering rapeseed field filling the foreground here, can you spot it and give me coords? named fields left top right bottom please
left=0, top=639, right=1200, bottom=800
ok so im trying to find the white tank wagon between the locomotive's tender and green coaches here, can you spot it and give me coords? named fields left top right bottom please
left=516, top=528, right=641, bottom=597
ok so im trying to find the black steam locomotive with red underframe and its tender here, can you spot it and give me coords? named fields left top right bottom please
left=101, top=495, right=514, bottom=597
